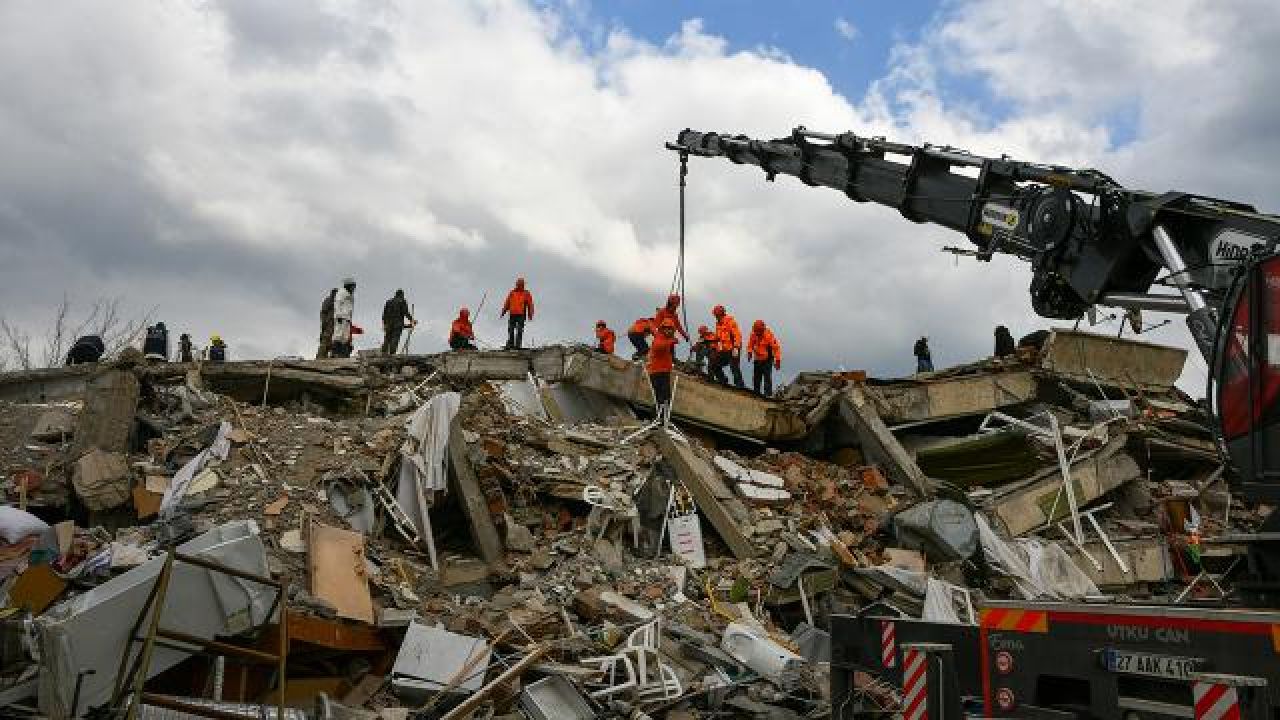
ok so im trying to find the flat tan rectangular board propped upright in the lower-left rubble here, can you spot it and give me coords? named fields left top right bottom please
left=307, top=520, right=374, bottom=624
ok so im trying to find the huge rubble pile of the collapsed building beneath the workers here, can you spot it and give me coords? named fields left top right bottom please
left=0, top=333, right=1260, bottom=719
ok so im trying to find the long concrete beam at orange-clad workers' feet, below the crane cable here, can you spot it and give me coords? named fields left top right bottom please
left=564, top=350, right=808, bottom=442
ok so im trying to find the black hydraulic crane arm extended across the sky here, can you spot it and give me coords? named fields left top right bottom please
left=672, top=127, right=1280, bottom=356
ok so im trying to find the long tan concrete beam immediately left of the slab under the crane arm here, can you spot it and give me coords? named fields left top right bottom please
left=876, top=370, right=1036, bottom=425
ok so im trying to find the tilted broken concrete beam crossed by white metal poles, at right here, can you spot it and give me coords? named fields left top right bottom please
left=987, top=434, right=1142, bottom=537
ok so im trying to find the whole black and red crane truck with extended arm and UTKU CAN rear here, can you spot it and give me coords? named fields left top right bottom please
left=668, top=127, right=1280, bottom=720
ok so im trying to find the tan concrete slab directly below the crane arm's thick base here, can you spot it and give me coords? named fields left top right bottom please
left=1039, top=329, right=1187, bottom=391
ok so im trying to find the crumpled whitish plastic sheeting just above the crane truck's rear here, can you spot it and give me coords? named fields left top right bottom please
left=974, top=514, right=1100, bottom=600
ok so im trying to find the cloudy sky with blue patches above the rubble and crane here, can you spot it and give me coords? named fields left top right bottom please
left=0, top=0, right=1280, bottom=392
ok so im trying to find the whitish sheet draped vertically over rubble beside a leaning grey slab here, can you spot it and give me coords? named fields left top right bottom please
left=396, top=392, right=462, bottom=537
